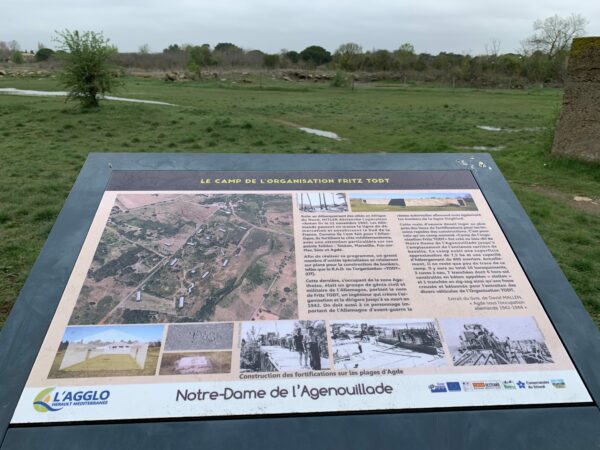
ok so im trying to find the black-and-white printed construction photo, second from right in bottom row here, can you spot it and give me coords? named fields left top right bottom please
left=331, top=319, right=446, bottom=370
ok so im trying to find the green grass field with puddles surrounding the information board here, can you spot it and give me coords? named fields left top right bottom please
left=0, top=77, right=600, bottom=324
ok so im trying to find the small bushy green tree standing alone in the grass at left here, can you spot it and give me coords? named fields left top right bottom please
left=56, top=30, right=121, bottom=108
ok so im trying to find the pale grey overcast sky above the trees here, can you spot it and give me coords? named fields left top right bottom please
left=0, top=0, right=600, bottom=54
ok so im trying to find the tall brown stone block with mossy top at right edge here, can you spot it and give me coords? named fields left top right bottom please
left=552, top=37, right=600, bottom=161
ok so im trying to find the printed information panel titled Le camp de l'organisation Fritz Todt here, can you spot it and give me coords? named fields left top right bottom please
left=12, top=170, right=592, bottom=423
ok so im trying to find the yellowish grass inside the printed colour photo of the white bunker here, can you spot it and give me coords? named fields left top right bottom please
left=48, top=347, right=160, bottom=378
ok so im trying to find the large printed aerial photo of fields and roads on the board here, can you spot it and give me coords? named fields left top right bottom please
left=70, top=193, right=298, bottom=325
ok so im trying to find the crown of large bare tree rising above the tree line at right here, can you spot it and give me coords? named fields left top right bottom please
left=522, top=14, right=587, bottom=58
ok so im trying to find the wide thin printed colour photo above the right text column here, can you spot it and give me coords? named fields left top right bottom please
left=350, top=192, right=477, bottom=212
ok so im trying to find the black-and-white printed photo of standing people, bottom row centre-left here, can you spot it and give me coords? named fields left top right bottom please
left=240, top=320, right=330, bottom=372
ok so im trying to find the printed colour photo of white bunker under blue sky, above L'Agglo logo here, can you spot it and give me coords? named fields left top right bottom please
left=48, top=325, right=163, bottom=378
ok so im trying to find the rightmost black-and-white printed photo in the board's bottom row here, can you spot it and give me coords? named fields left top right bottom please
left=441, top=316, right=554, bottom=366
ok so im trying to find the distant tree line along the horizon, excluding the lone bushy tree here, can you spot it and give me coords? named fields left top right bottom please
left=0, top=14, right=587, bottom=86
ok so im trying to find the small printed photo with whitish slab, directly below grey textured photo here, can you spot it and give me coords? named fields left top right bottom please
left=159, top=352, right=231, bottom=375
